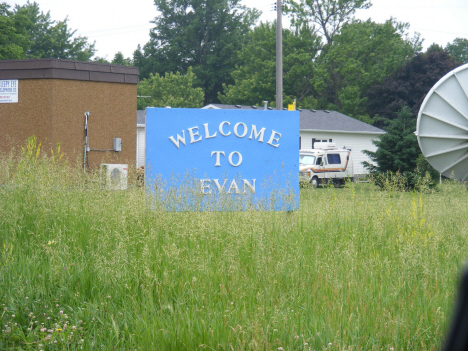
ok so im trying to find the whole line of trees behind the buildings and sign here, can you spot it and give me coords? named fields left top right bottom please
left=0, top=0, right=468, bottom=177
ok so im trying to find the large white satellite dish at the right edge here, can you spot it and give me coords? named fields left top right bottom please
left=415, top=64, right=468, bottom=181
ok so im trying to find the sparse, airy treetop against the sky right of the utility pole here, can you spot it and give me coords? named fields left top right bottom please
left=285, top=0, right=371, bottom=45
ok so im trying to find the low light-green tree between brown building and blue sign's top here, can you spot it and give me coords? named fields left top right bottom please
left=137, top=67, right=204, bottom=110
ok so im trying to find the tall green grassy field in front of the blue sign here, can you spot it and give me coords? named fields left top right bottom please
left=0, top=144, right=468, bottom=350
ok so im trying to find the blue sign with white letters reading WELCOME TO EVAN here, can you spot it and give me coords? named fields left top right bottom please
left=146, top=108, right=299, bottom=211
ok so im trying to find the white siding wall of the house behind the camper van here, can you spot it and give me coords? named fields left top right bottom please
left=299, top=130, right=379, bottom=175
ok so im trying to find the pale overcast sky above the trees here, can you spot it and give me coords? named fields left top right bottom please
left=0, top=0, right=468, bottom=60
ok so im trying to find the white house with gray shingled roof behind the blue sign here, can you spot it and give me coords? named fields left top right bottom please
left=202, top=104, right=385, bottom=175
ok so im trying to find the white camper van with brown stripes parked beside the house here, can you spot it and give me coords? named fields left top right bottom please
left=299, top=142, right=354, bottom=188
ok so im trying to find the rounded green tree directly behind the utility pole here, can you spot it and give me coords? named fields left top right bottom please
left=218, top=23, right=320, bottom=108
